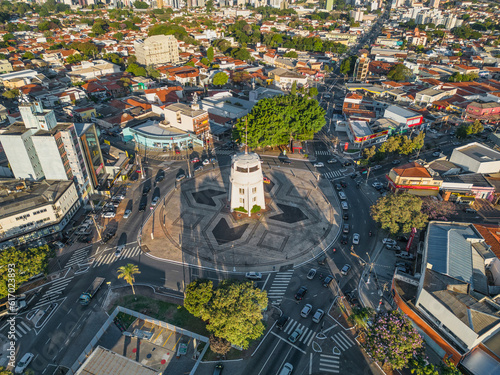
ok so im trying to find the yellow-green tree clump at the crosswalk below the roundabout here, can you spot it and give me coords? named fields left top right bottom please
left=184, top=280, right=268, bottom=349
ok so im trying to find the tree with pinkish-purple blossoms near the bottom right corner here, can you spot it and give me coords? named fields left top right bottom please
left=364, top=310, right=423, bottom=370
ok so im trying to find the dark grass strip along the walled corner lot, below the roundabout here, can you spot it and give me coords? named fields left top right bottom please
left=108, top=295, right=209, bottom=336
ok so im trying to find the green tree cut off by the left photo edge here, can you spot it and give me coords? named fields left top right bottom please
left=0, top=245, right=50, bottom=298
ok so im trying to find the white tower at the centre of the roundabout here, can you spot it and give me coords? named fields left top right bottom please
left=229, top=152, right=266, bottom=216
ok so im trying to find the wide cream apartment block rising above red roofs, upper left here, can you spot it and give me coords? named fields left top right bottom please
left=134, top=35, right=179, bottom=65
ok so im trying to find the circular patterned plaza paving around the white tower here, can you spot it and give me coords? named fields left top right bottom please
left=141, top=167, right=341, bottom=272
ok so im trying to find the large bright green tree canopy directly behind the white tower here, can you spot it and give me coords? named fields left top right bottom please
left=233, top=95, right=326, bottom=148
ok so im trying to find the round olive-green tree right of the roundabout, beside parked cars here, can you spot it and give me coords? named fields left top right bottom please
left=370, top=193, right=428, bottom=235
